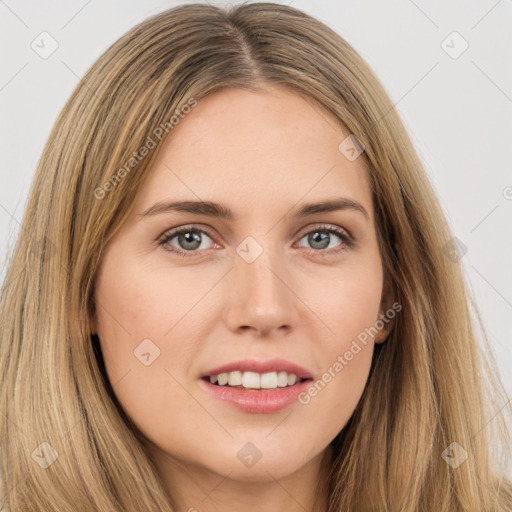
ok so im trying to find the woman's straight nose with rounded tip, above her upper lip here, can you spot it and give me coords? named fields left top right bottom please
left=225, top=246, right=301, bottom=337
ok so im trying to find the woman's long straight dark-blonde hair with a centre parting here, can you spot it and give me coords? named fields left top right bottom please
left=0, top=3, right=512, bottom=512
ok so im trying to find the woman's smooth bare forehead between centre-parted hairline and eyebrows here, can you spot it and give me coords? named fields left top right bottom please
left=132, top=88, right=373, bottom=224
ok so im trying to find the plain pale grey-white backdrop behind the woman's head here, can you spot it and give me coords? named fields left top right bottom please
left=0, top=0, right=512, bottom=470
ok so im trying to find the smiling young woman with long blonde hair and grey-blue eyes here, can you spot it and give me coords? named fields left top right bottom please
left=0, top=3, right=512, bottom=512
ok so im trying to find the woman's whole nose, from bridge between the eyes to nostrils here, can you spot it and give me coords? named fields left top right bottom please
left=227, top=236, right=297, bottom=333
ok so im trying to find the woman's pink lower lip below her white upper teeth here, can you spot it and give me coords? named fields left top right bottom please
left=199, top=379, right=311, bottom=413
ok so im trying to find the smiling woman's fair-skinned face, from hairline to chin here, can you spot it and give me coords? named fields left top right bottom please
left=94, top=88, right=392, bottom=488
